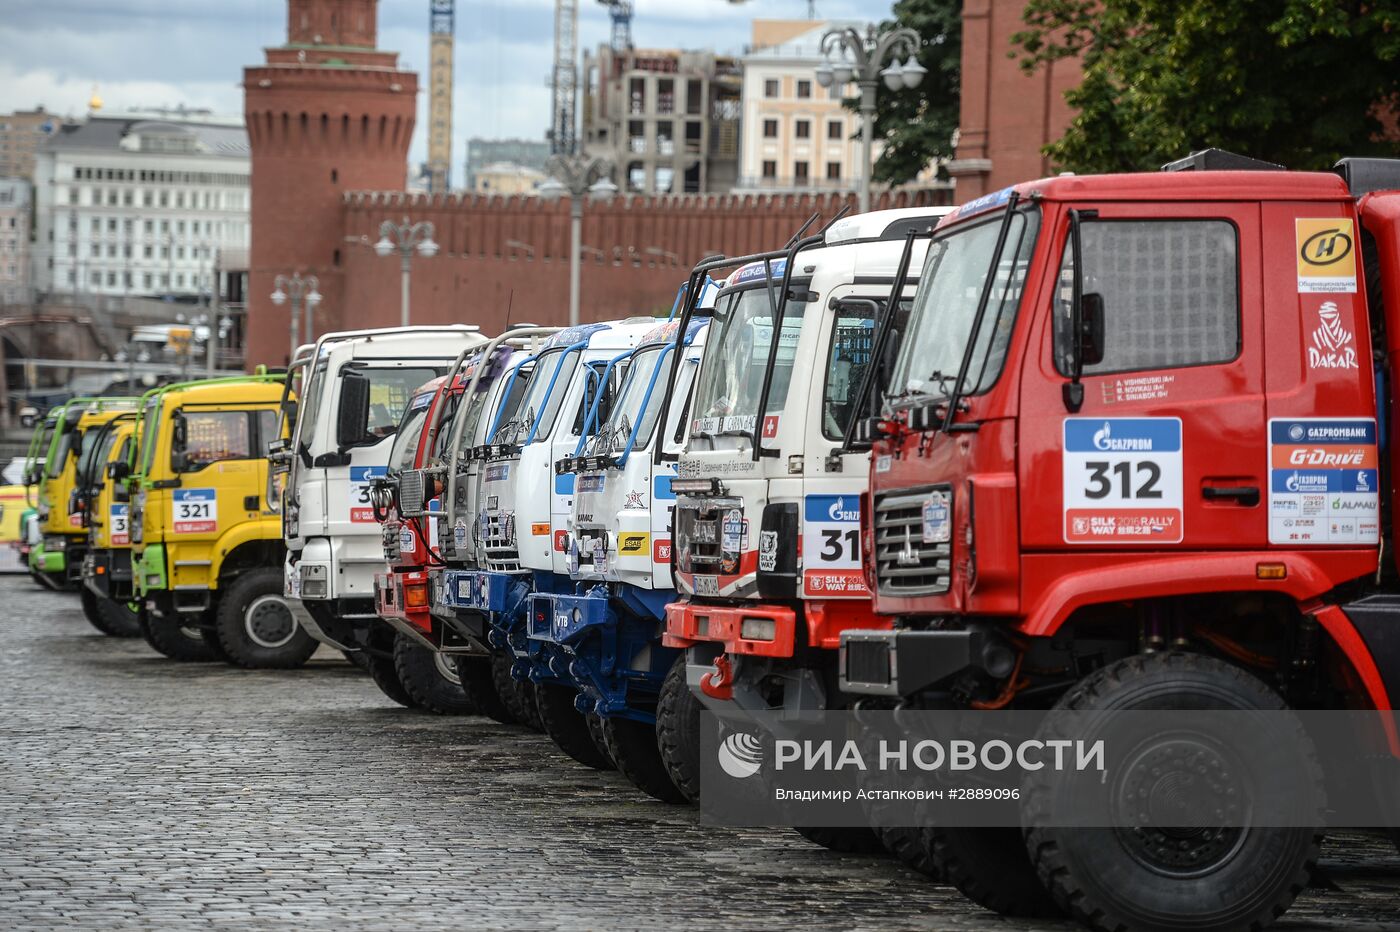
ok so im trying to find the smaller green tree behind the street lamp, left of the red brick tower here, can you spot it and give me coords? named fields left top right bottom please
left=847, top=0, right=962, bottom=185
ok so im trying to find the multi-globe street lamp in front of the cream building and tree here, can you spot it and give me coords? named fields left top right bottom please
left=816, top=24, right=928, bottom=214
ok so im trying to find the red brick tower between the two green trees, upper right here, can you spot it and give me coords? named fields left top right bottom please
left=952, top=0, right=1079, bottom=203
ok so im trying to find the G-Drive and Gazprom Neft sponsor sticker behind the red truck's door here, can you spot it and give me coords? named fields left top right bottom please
left=1268, top=417, right=1380, bottom=546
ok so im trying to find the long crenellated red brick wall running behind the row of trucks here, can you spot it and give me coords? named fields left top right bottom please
left=248, top=184, right=946, bottom=367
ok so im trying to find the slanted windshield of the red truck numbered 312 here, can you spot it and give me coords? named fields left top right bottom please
left=889, top=210, right=1040, bottom=397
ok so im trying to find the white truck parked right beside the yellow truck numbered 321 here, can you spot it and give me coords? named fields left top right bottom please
left=273, top=325, right=486, bottom=682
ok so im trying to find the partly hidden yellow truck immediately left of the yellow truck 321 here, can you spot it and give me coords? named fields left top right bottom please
left=77, top=410, right=141, bottom=638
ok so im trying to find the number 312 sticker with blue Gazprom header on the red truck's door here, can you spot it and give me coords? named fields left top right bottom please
left=1063, top=417, right=1183, bottom=544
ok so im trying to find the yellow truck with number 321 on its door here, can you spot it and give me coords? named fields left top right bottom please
left=119, top=375, right=316, bottom=668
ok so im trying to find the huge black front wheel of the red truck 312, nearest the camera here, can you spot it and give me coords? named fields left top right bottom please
left=1022, top=652, right=1322, bottom=932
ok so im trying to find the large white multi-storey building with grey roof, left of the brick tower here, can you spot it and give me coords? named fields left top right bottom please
left=32, top=111, right=251, bottom=298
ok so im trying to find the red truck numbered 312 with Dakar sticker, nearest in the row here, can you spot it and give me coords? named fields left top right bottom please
left=840, top=150, right=1400, bottom=929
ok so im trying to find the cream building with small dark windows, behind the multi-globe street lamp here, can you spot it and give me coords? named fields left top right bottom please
left=738, top=20, right=879, bottom=192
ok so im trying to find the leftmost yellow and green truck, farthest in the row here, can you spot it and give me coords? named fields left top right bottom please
left=38, top=397, right=136, bottom=589
